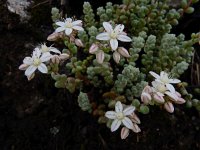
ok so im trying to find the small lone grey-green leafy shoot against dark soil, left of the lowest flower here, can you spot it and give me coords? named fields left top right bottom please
left=78, top=92, right=92, bottom=112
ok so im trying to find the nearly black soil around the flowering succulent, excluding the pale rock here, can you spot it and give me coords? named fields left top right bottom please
left=0, top=0, right=200, bottom=150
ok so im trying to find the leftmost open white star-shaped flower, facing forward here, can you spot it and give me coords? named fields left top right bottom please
left=19, top=49, right=52, bottom=77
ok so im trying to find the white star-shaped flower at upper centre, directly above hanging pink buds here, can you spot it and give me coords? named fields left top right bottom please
left=96, top=22, right=132, bottom=50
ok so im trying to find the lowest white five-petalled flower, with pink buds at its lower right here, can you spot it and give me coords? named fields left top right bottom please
left=105, top=101, right=135, bottom=132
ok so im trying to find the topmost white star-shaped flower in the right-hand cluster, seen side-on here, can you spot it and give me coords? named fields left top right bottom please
left=149, top=71, right=181, bottom=93
